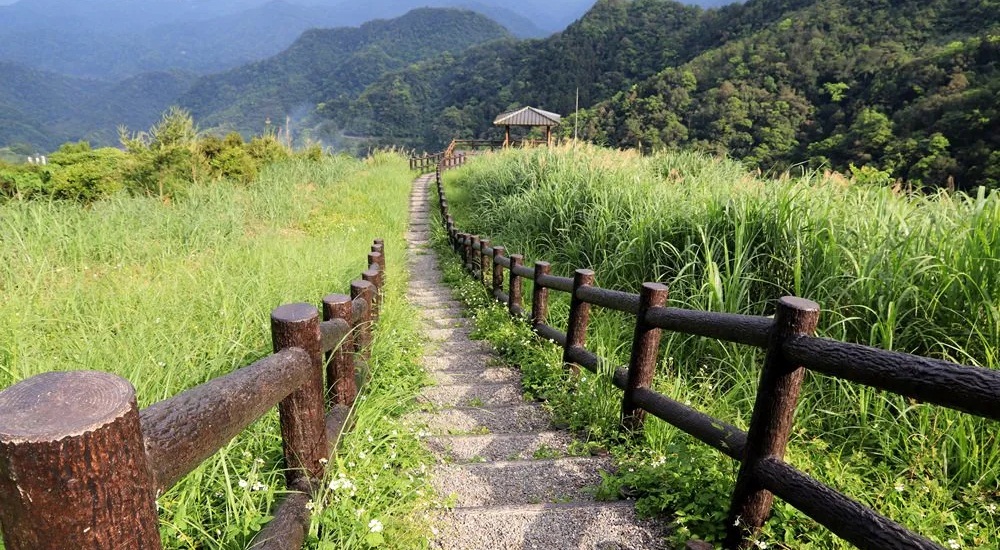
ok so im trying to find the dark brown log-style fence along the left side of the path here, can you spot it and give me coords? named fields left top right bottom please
left=0, top=239, right=385, bottom=550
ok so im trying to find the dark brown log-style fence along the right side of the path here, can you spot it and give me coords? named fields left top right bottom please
left=437, top=164, right=1000, bottom=550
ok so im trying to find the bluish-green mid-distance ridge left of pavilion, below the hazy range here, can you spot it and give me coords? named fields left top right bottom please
left=179, top=8, right=510, bottom=139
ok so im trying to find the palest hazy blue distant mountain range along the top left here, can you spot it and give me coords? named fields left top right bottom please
left=0, top=0, right=572, bottom=79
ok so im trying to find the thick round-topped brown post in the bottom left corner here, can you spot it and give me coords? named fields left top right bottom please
left=0, top=371, right=161, bottom=550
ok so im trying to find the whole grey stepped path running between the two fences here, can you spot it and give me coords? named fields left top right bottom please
left=407, top=176, right=665, bottom=550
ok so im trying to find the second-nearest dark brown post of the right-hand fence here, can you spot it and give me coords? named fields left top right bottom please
left=622, top=283, right=669, bottom=433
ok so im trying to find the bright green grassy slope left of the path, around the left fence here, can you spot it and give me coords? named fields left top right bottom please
left=0, top=155, right=438, bottom=548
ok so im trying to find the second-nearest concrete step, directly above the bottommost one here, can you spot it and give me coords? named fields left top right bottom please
left=431, top=457, right=612, bottom=507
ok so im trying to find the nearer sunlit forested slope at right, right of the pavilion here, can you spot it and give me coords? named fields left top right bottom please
left=580, top=0, right=1000, bottom=188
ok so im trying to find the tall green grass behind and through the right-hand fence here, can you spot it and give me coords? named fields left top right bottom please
left=446, top=144, right=1000, bottom=548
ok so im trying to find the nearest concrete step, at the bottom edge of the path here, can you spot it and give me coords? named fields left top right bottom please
left=431, top=502, right=668, bottom=550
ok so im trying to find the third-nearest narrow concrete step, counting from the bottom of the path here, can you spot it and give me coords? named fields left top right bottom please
left=426, top=432, right=573, bottom=462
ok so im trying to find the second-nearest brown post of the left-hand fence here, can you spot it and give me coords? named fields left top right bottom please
left=271, top=304, right=330, bottom=491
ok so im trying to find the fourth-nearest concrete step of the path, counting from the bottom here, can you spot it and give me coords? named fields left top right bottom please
left=411, top=403, right=552, bottom=435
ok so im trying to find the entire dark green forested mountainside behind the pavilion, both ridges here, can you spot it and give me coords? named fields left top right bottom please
left=346, top=0, right=1000, bottom=187
